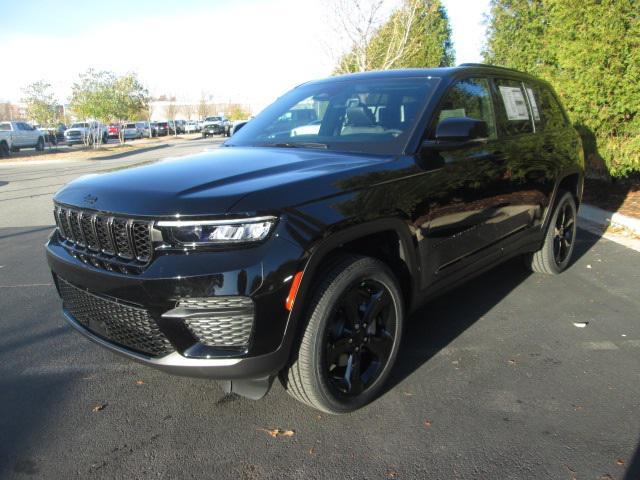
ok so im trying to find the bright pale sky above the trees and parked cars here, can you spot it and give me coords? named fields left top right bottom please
left=0, top=0, right=489, bottom=113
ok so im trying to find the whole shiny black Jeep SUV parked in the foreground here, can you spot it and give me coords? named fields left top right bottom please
left=46, top=65, right=584, bottom=413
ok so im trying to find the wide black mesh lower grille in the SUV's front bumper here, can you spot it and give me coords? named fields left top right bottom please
left=57, top=277, right=175, bottom=357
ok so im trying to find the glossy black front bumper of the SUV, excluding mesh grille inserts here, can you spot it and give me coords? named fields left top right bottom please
left=46, top=227, right=304, bottom=380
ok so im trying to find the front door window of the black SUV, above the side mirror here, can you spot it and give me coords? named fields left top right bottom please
left=437, top=78, right=497, bottom=138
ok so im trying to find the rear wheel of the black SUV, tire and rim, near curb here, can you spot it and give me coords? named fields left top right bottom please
left=525, top=191, right=578, bottom=275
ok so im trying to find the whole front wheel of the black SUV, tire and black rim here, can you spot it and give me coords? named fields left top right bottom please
left=281, top=256, right=404, bottom=414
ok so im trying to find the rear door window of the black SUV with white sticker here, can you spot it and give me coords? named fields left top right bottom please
left=496, top=79, right=539, bottom=135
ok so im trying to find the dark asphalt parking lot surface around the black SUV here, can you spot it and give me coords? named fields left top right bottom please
left=0, top=140, right=640, bottom=480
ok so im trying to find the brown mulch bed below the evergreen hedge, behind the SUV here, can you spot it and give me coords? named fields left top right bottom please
left=583, top=179, right=640, bottom=218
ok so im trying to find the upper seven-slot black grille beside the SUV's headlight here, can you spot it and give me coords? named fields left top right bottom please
left=54, top=206, right=153, bottom=270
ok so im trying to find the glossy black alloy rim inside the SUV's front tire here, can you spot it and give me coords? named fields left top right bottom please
left=323, top=279, right=396, bottom=396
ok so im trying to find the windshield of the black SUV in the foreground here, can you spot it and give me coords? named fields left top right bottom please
left=226, top=77, right=439, bottom=154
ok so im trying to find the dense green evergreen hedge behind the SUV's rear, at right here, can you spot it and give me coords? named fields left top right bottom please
left=484, top=0, right=640, bottom=176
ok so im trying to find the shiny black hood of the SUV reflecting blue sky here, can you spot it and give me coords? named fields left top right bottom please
left=55, top=147, right=393, bottom=216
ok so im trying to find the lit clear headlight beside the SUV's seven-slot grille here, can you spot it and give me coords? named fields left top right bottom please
left=158, top=217, right=276, bottom=246
